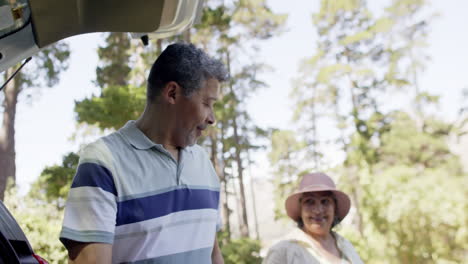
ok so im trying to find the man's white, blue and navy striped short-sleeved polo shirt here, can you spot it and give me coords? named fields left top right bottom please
left=60, top=121, right=220, bottom=263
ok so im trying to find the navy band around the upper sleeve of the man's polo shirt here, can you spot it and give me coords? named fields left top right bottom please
left=71, top=163, right=117, bottom=196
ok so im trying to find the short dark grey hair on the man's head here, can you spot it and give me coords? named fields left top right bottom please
left=147, top=43, right=229, bottom=101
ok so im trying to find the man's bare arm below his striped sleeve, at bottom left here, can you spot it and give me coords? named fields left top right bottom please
left=65, top=240, right=112, bottom=264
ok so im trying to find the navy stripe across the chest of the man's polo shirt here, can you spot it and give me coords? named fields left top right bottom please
left=116, top=188, right=219, bottom=226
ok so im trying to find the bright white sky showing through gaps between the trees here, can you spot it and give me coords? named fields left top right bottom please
left=10, top=0, right=468, bottom=192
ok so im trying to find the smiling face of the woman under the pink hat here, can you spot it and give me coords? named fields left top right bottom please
left=300, top=191, right=336, bottom=236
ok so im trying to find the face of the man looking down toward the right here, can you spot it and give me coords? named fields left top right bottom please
left=175, top=78, right=219, bottom=147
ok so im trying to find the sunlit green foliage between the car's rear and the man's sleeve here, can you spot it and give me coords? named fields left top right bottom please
left=5, top=183, right=68, bottom=264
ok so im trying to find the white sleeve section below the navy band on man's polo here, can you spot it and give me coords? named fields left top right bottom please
left=63, top=187, right=117, bottom=233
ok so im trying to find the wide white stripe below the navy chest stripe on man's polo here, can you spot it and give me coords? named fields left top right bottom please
left=112, top=209, right=217, bottom=262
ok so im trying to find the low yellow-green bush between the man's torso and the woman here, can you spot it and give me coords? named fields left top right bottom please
left=218, top=232, right=262, bottom=264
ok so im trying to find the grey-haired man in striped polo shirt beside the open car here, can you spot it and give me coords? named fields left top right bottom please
left=60, top=43, right=227, bottom=263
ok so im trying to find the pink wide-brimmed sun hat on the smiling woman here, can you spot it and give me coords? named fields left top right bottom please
left=285, top=172, right=351, bottom=222
